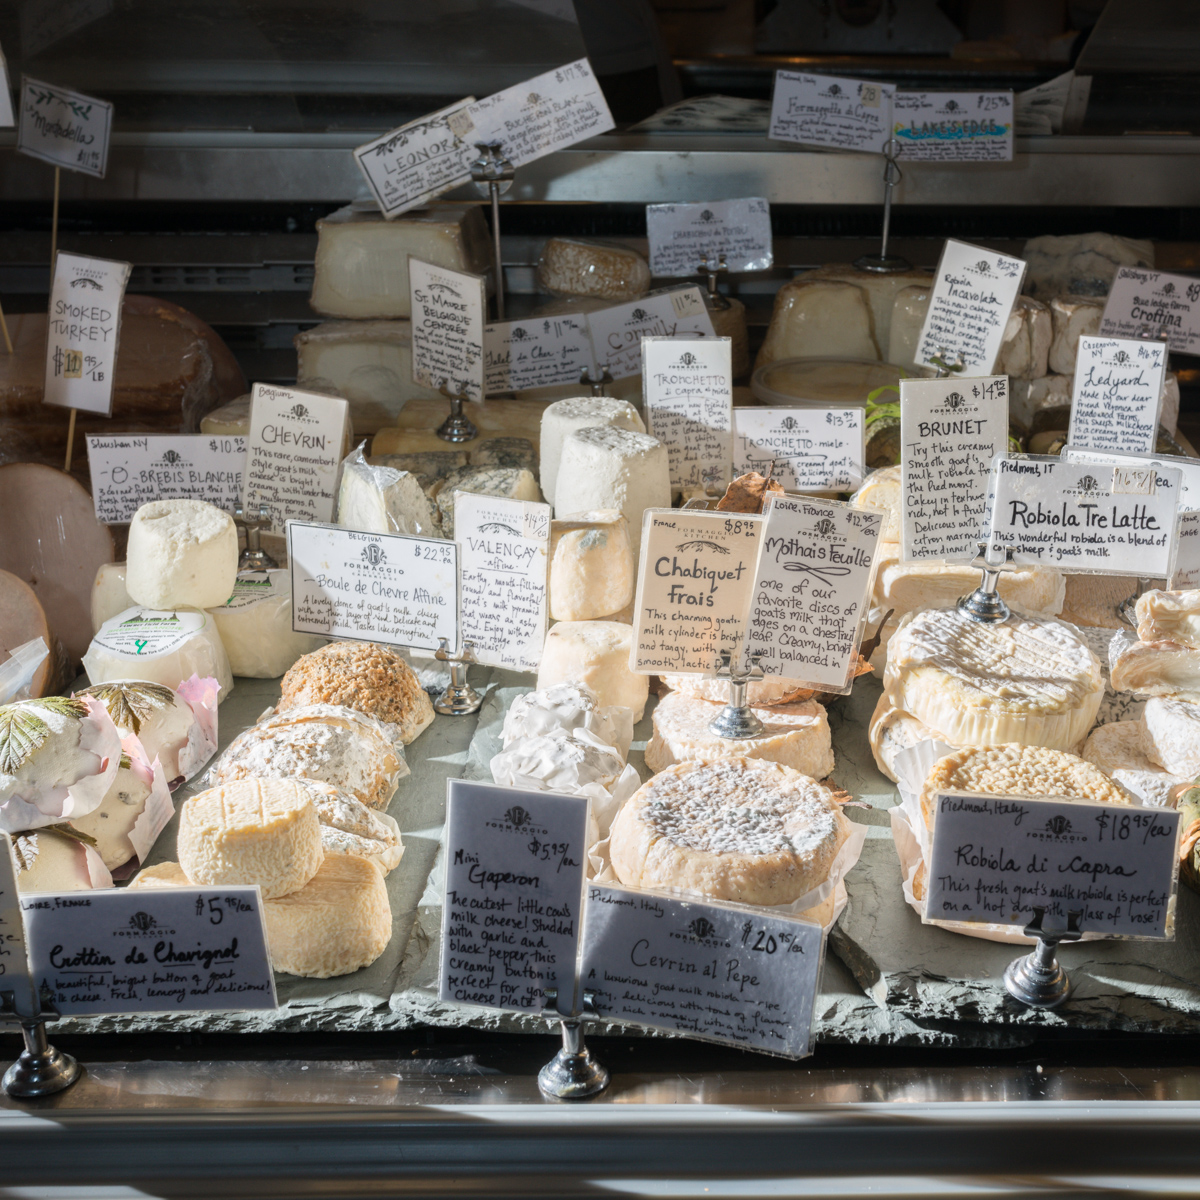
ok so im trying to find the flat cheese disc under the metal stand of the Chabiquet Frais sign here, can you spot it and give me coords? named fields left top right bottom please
left=646, top=692, right=834, bottom=779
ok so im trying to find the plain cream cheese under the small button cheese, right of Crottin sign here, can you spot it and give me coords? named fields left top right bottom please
left=263, top=854, right=391, bottom=979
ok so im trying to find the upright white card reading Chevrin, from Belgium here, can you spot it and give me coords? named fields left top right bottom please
left=245, top=383, right=350, bottom=533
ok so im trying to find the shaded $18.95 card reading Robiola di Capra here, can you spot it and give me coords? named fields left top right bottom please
left=925, top=792, right=1180, bottom=938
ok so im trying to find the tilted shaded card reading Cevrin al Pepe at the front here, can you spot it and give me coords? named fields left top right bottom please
left=580, top=883, right=824, bottom=1058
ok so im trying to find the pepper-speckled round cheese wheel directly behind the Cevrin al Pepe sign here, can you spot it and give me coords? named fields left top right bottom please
left=608, top=758, right=850, bottom=905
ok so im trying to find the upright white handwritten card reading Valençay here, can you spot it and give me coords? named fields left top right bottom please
left=454, top=492, right=550, bottom=671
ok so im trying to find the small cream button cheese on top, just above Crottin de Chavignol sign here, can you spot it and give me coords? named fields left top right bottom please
left=176, top=779, right=325, bottom=900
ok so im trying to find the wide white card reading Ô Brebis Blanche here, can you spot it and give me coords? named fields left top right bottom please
left=88, top=433, right=246, bottom=524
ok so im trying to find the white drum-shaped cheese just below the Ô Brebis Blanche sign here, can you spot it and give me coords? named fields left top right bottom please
left=125, top=500, right=238, bottom=608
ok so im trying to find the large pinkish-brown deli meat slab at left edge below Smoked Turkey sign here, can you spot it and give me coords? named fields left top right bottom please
left=0, top=460, right=115, bottom=667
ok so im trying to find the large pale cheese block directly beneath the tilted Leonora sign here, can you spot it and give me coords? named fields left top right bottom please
left=310, top=205, right=490, bottom=320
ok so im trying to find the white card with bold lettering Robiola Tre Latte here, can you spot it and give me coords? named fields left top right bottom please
left=989, top=458, right=1180, bottom=580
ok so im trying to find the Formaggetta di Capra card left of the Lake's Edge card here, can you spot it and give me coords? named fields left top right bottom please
left=767, top=71, right=895, bottom=154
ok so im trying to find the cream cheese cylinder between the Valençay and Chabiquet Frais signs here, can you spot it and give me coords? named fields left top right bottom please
left=550, top=509, right=635, bottom=620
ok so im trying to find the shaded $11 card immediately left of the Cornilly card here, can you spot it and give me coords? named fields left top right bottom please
left=484, top=313, right=593, bottom=396
